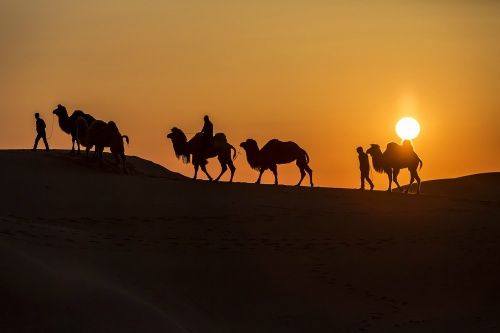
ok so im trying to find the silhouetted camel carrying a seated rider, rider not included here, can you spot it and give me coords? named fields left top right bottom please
left=167, top=127, right=236, bottom=182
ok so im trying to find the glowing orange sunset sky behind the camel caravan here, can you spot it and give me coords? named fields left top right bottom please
left=0, top=0, right=500, bottom=188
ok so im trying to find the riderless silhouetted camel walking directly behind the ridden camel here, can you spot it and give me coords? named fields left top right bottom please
left=240, top=139, right=314, bottom=187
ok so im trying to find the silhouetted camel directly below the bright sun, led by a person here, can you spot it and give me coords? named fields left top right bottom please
left=366, top=140, right=423, bottom=194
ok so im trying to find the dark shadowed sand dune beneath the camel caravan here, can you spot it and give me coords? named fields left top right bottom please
left=0, top=151, right=500, bottom=332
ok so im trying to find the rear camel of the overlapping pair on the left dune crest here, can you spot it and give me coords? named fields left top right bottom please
left=77, top=117, right=130, bottom=173
